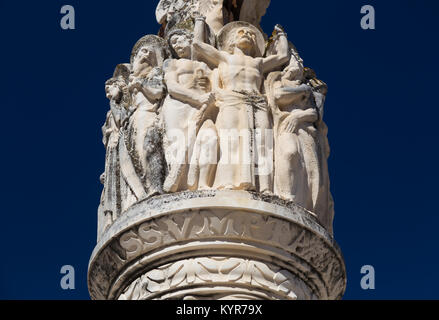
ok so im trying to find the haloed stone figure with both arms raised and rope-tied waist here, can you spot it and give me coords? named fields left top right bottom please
left=193, top=17, right=289, bottom=193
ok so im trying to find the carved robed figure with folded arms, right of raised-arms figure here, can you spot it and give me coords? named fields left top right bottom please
left=265, top=50, right=332, bottom=231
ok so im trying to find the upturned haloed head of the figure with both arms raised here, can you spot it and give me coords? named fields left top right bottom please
left=218, top=21, right=265, bottom=57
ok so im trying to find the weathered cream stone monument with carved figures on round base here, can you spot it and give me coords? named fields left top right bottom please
left=88, top=0, right=346, bottom=300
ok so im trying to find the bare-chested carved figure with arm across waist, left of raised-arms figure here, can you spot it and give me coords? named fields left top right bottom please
left=162, top=29, right=216, bottom=192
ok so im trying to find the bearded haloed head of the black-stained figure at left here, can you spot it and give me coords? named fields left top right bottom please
left=131, top=35, right=169, bottom=75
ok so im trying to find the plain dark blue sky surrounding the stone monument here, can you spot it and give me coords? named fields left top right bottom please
left=0, top=0, right=439, bottom=299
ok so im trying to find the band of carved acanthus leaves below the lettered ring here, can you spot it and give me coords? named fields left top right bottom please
left=119, top=257, right=313, bottom=299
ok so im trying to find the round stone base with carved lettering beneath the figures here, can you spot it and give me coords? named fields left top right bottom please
left=88, top=191, right=346, bottom=300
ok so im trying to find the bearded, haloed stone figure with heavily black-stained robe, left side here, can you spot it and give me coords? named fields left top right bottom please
left=121, top=35, right=169, bottom=209
